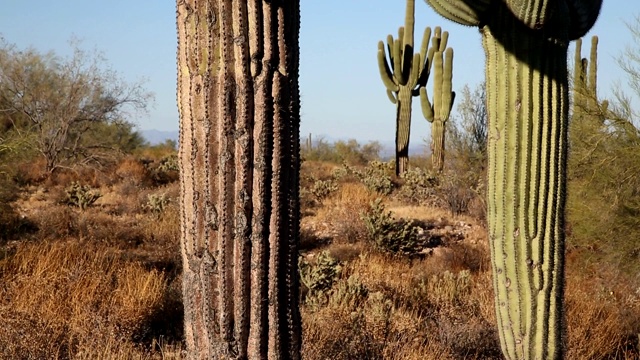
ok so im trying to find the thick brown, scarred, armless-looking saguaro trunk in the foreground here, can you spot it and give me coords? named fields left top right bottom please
left=177, top=0, right=301, bottom=359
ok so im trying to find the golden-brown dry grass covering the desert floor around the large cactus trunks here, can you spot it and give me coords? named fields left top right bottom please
left=0, top=155, right=640, bottom=360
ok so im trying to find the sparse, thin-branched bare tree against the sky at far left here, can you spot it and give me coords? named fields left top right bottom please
left=0, top=43, right=151, bottom=173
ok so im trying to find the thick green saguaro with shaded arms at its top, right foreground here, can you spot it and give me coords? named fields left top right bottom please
left=427, top=0, right=602, bottom=359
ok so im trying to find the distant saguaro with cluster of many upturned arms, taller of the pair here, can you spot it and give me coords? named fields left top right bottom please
left=378, top=0, right=448, bottom=175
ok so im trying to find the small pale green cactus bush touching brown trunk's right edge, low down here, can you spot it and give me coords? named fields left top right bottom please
left=298, top=251, right=342, bottom=306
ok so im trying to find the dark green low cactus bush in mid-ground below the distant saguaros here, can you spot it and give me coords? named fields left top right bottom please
left=360, top=198, right=425, bottom=256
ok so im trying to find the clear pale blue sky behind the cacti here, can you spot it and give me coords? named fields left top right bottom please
left=0, top=0, right=640, bottom=148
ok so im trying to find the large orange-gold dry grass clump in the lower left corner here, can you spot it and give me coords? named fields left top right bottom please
left=0, top=239, right=182, bottom=359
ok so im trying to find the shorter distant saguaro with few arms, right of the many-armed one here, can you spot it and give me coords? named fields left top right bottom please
left=420, top=39, right=456, bottom=172
